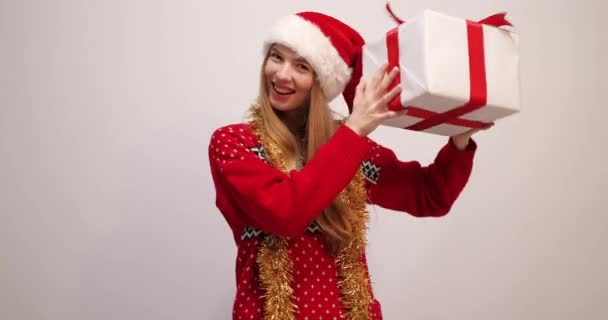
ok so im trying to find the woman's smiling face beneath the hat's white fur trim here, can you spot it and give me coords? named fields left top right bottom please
left=264, top=44, right=314, bottom=112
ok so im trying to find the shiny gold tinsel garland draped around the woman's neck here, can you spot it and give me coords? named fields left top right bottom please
left=250, top=105, right=372, bottom=320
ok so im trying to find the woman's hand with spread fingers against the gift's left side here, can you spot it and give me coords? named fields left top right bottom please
left=345, top=63, right=406, bottom=136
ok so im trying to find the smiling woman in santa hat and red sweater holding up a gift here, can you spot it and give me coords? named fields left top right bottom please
left=209, top=12, right=484, bottom=320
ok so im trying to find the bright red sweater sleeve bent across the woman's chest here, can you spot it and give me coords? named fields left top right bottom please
left=209, top=125, right=371, bottom=237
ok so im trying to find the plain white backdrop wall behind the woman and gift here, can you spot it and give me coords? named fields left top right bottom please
left=0, top=0, right=608, bottom=320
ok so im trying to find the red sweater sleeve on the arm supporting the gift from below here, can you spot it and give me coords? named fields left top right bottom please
left=368, top=139, right=477, bottom=217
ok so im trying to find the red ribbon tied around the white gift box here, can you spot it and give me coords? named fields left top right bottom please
left=386, top=3, right=511, bottom=131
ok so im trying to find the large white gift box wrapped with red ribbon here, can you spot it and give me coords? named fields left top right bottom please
left=362, top=10, right=520, bottom=136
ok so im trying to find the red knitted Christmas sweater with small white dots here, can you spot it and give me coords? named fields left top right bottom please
left=209, top=124, right=476, bottom=319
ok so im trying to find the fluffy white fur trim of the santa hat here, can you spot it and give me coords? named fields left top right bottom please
left=264, top=15, right=352, bottom=101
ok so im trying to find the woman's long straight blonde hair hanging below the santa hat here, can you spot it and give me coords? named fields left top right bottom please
left=258, top=52, right=356, bottom=255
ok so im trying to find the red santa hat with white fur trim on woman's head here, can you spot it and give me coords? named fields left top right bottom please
left=264, top=12, right=365, bottom=109
